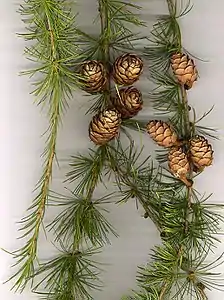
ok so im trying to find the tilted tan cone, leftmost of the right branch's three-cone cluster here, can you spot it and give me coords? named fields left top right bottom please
left=147, top=120, right=178, bottom=147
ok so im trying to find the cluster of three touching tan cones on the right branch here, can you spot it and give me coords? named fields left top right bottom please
left=147, top=120, right=213, bottom=187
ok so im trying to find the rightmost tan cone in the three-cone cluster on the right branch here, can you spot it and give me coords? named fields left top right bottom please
left=190, top=136, right=213, bottom=171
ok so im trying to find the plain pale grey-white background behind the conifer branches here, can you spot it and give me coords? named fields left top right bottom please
left=0, top=0, right=224, bottom=300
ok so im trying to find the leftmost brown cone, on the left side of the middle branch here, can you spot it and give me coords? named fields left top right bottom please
left=80, top=60, right=107, bottom=93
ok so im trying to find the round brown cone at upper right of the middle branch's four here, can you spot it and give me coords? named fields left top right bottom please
left=112, top=54, right=143, bottom=85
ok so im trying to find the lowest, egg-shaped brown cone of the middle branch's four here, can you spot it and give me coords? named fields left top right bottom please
left=89, top=109, right=121, bottom=145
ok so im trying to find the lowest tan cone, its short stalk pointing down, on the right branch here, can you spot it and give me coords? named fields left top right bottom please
left=168, top=147, right=192, bottom=187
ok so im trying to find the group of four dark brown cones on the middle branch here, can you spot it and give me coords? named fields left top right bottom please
left=81, top=53, right=143, bottom=145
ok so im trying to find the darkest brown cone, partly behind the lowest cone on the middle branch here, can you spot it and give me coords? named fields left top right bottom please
left=113, top=86, right=143, bottom=119
